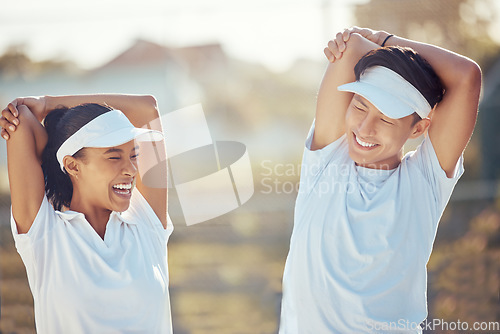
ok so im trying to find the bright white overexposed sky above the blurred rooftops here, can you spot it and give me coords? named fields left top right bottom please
left=0, top=0, right=366, bottom=71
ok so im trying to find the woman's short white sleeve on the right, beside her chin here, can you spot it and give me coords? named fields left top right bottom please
left=122, top=188, right=174, bottom=240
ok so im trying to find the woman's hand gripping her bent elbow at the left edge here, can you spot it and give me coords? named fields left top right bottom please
left=0, top=96, right=46, bottom=140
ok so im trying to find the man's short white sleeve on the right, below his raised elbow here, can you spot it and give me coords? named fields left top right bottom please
left=408, top=136, right=464, bottom=210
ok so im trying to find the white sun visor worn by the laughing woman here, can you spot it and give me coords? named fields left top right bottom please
left=56, top=110, right=163, bottom=172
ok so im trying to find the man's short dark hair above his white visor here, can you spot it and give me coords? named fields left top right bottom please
left=354, top=46, right=444, bottom=123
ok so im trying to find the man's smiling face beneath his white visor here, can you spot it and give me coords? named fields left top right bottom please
left=346, top=94, right=428, bottom=169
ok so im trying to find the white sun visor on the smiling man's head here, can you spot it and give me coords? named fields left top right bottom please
left=337, top=66, right=432, bottom=119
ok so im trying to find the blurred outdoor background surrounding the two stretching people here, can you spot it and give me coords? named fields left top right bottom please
left=0, top=0, right=500, bottom=334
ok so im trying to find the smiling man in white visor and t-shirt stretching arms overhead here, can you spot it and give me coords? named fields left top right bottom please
left=280, top=27, right=481, bottom=334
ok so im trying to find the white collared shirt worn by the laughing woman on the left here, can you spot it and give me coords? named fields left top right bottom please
left=11, top=189, right=173, bottom=334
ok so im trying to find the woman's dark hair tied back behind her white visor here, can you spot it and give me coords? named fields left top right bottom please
left=42, top=103, right=112, bottom=210
